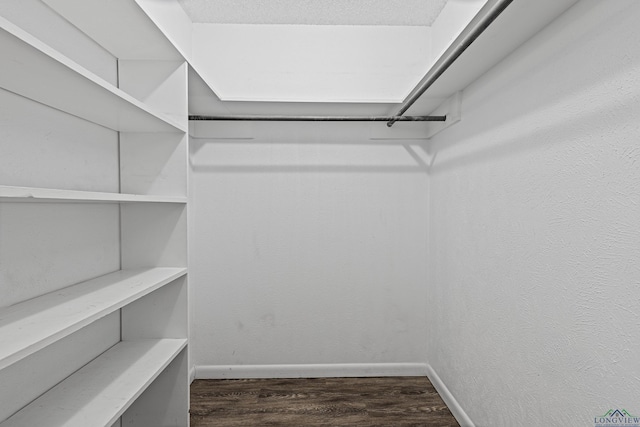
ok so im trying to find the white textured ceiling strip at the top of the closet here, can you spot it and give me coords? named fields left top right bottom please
left=178, top=0, right=447, bottom=26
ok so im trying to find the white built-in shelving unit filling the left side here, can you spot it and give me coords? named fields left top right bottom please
left=0, top=0, right=189, bottom=427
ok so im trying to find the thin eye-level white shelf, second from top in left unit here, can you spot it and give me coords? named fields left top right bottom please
left=0, top=185, right=187, bottom=203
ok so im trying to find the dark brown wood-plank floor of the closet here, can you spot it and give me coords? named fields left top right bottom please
left=191, top=377, right=458, bottom=427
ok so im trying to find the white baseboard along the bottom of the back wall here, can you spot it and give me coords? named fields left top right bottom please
left=195, top=363, right=427, bottom=379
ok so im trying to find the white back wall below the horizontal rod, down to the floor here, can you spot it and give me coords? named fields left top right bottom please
left=189, top=122, right=427, bottom=378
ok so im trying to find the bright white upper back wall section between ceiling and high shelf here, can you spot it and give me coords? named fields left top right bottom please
left=192, top=24, right=431, bottom=102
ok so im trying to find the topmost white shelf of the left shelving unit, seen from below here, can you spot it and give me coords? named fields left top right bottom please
left=0, top=17, right=187, bottom=132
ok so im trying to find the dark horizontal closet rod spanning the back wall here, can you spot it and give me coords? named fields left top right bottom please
left=189, top=116, right=447, bottom=122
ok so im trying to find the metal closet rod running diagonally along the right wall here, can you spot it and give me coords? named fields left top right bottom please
left=387, top=0, right=513, bottom=127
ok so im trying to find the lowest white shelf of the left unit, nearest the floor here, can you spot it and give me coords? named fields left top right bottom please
left=0, top=339, right=187, bottom=427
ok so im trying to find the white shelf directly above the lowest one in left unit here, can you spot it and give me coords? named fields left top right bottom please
left=0, top=268, right=187, bottom=372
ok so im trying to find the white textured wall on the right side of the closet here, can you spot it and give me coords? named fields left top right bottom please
left=426, top=0, right=640, bottom=427
